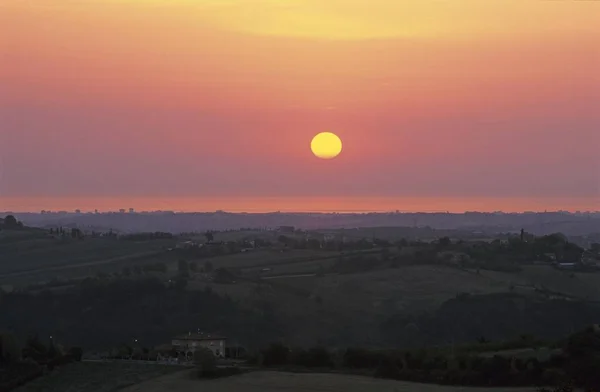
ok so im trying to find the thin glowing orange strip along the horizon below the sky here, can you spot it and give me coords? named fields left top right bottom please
left=0, top=196, right=600, bottom=213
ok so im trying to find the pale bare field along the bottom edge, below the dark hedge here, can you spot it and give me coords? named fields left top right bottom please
left=123, top=372, right=535, bottom=392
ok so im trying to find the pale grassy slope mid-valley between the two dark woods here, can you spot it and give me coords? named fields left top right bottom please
left=189, top=266, right=508, bottom=345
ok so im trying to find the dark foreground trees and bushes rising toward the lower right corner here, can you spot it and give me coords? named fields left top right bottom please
left=250, top=326, right=600, bottom=391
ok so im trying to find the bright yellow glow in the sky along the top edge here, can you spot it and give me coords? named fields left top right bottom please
left=191, top=0, right=589, bottom=40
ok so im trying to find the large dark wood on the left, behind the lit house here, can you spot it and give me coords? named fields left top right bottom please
left=0, top=278, right=279, bottom=350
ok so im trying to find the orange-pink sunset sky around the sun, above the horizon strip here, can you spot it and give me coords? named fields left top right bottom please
left=0, top=0, right=600, bottom=210
